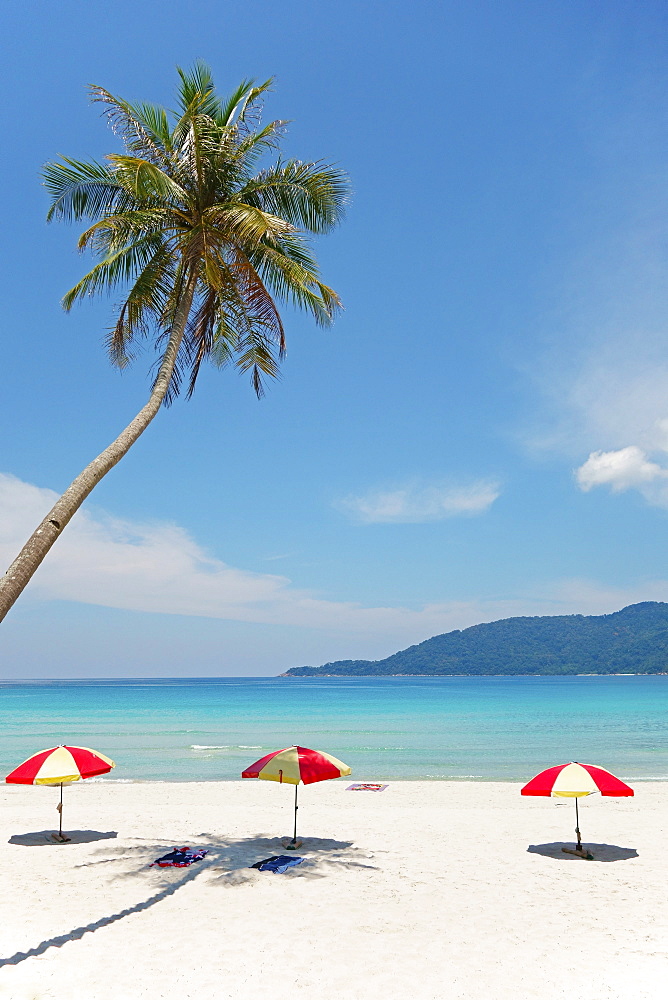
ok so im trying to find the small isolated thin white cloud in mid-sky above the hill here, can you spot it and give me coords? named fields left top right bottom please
left=336, top=481, right=500, bottom=524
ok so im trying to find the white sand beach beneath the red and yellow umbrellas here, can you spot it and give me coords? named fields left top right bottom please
left=0, top=779, right=668, bottom=1000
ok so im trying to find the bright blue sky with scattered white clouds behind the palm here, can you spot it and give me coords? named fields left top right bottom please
left=0, top=0, right=668, bottom=677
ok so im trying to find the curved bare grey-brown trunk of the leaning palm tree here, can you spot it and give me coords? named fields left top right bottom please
left=0, top=276, right=196, bottom=622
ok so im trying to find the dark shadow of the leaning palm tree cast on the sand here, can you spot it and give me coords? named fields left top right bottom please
left=0, top=830, right=375, bottom=968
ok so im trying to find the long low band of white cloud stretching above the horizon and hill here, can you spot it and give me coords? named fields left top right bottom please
left=0, top=474, right=668, bottom=657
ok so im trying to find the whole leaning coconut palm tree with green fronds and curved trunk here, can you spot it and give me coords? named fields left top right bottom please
left=0, top=63, right=347, bottom=621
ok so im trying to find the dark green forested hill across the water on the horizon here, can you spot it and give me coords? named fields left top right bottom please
left=282, top=601, right=668, bottom=677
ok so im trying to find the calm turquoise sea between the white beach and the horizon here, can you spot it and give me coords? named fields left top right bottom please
left=0, top=677, right=668, bottom=781
